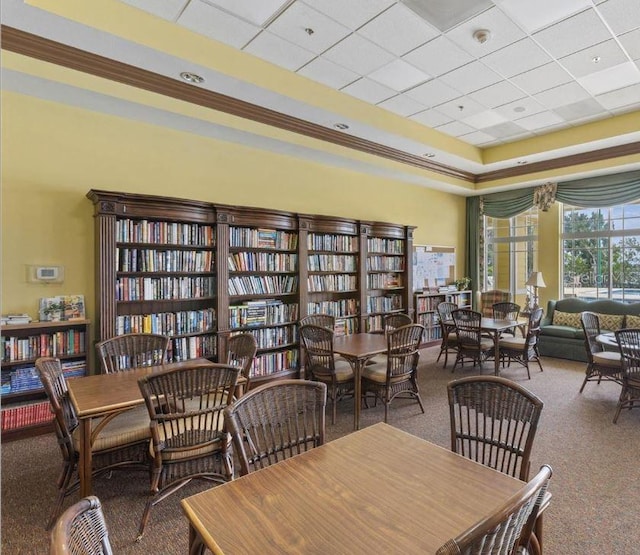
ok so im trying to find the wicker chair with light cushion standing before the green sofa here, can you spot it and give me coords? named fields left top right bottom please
left=580, top=311, right=622, bottom=393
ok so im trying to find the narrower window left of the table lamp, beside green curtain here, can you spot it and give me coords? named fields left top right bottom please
left=483, top=207, right=538, bottom=304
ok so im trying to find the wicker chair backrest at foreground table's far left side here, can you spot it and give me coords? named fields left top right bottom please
left=224, top=380, right=327, bottom=476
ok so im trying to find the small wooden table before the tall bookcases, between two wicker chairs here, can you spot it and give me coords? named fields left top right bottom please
left=333, top=333, right=387, bottom=430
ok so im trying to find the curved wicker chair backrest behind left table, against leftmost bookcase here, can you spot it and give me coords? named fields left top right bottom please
left=96, top=333, right=169, bottom=374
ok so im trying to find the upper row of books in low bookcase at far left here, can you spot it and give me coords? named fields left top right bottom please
left=0, top=329, right=87, bottom=362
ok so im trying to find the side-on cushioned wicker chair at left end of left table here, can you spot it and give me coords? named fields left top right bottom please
left=35, top=357, right=151, bottom=530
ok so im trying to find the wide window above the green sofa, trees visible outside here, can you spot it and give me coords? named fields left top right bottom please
left=562, top=201, right=640, bottom=302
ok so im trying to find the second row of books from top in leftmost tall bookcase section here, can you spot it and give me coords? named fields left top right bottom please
left=116, top=249, right=214, bottom=272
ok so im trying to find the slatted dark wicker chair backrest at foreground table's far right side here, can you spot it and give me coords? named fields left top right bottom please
left=447, top=376, right=544, bottom=481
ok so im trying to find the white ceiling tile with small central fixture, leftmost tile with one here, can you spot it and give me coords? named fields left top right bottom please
left=267, top=2, right=351, bottom=54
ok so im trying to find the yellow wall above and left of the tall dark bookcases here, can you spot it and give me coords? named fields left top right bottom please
left=2, top=92, right=465, bottom=326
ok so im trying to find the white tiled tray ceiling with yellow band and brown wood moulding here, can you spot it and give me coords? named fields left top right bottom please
left=2, top=0, right=640, bottom=195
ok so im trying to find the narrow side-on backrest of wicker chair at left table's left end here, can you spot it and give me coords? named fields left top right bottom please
left=35, top=357, right=79, bottom=462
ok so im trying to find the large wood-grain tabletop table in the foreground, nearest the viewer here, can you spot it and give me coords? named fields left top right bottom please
left=181, top=423, right=523, bottom=555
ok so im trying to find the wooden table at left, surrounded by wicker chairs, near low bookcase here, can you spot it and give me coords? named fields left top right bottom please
left=67, top=358, right=245, bottom=497
